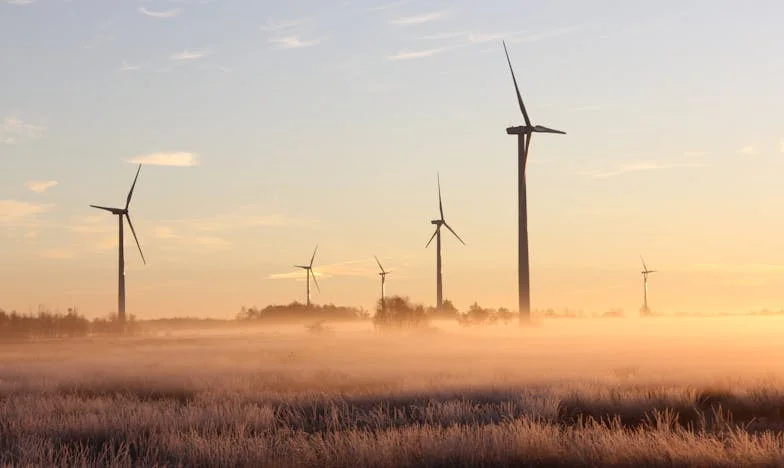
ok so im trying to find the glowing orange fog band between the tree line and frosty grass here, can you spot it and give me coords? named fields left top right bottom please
left=0, top=316, right=784, bottom=393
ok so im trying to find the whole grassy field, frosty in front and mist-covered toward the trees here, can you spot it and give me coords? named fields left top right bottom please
left=0, top=317, right=784, bottom=467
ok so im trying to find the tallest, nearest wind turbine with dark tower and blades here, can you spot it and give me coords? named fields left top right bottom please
left=504, top=42, right=566, bottom=324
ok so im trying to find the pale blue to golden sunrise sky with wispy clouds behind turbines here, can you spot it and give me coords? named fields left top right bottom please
left=0, top=0, right=784, bottom=318
